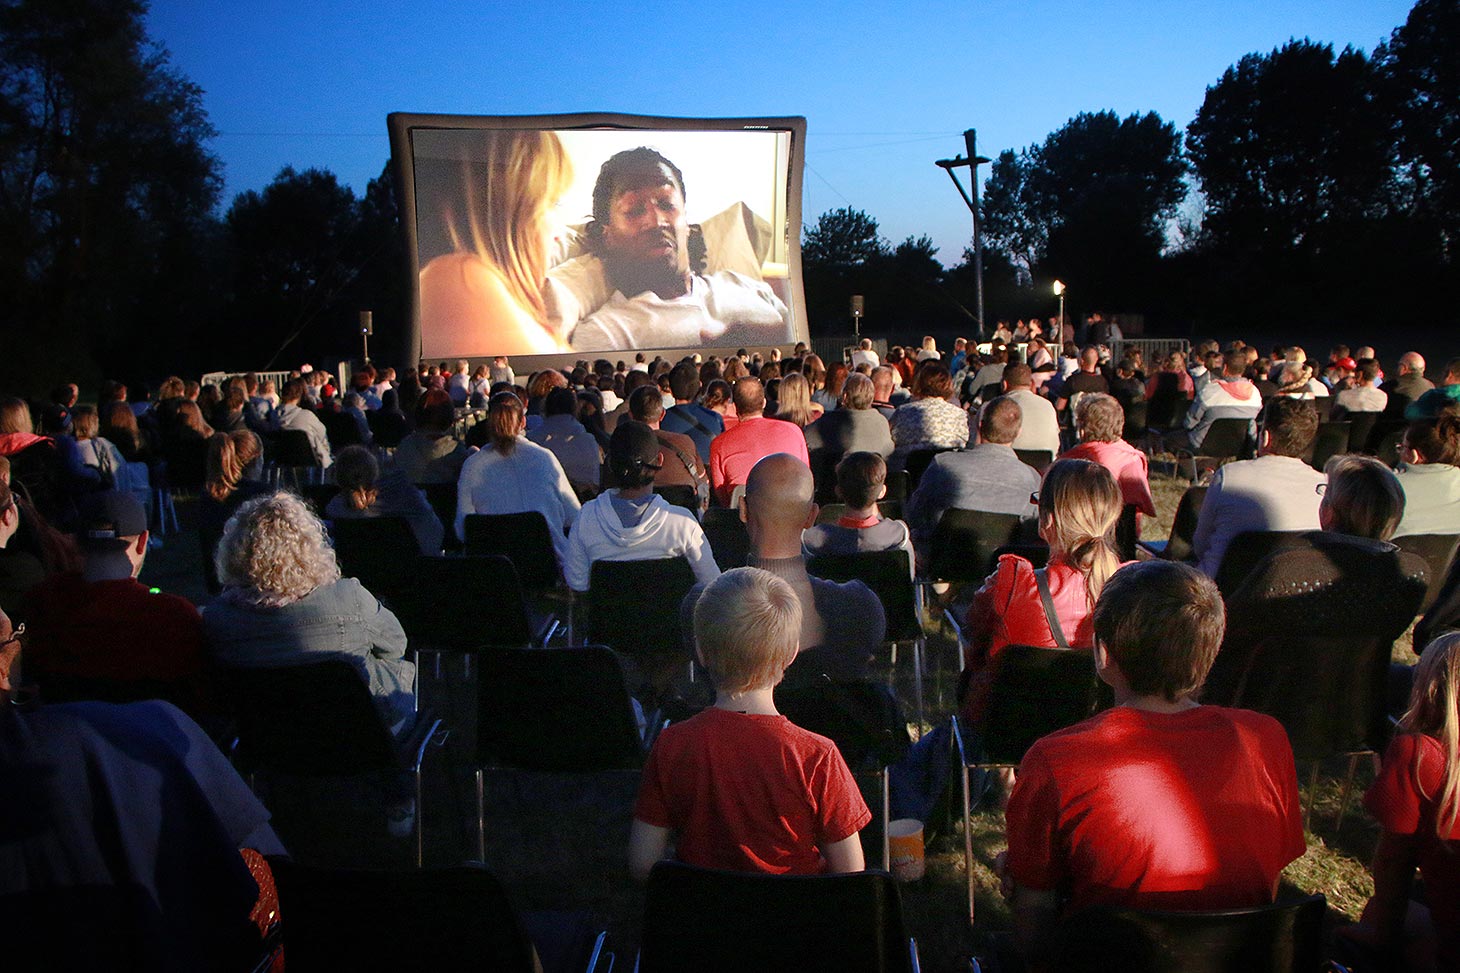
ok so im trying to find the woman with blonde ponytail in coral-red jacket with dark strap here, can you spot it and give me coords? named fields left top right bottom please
left=962, top=459, right=1121, bottom=725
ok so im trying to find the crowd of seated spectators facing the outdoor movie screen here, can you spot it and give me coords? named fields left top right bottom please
left=0, top=326, right=1460, bottom=960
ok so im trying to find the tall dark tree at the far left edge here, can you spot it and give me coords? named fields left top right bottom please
left=0, top=0, right=220, bottom=385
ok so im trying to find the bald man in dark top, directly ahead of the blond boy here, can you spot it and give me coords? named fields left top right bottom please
left=703, top=452, right=888, bottom=685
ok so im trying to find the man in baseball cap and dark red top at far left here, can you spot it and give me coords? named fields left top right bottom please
left=20, top=491, right=203, bottom=704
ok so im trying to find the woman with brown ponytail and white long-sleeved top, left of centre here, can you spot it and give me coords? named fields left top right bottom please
left=456, top=392, right=580, bottom=564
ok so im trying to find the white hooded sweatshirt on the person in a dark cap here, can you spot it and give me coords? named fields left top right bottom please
left=562, top=489, right=720, bottom=592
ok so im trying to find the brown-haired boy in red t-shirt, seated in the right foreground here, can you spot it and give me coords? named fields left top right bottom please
left=999, top=561, right=1305, bottom=969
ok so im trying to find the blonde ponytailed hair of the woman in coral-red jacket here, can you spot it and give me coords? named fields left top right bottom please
left=1040, top=459, right=1121, bottom=605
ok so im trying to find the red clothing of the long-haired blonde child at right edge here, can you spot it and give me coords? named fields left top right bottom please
left=1364, top=733, right=1460, bottom=970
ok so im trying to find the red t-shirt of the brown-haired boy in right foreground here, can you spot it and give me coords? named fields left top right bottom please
left=1004, top=706, right=1304, bottom=913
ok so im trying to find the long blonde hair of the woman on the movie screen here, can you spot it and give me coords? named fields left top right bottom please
left=447, top=129, right=572, bottom=321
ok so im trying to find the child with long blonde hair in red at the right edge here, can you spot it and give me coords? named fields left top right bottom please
left=1343, top=633, right=1460, bottom=970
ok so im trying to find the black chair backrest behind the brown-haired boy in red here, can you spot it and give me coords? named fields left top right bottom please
left=1056, top=896, right=1329, bottom=973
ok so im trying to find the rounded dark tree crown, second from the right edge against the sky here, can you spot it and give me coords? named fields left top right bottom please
left=1187, top=39, right=1394, bottom=253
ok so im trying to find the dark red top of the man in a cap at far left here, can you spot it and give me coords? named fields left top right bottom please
left=22, top=573, right=203, bottom=682
